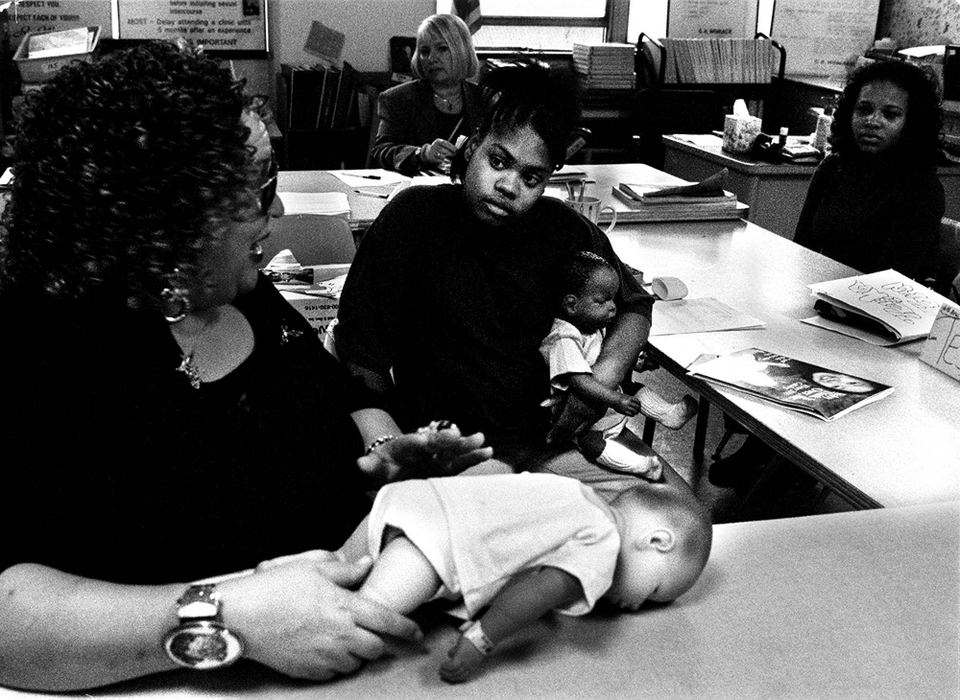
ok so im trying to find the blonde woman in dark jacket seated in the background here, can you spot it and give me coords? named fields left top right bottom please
left=370, top=14, right=480, bottom=175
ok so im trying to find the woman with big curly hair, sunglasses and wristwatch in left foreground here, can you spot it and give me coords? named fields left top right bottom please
left=0, top=42, right=490, bottom=690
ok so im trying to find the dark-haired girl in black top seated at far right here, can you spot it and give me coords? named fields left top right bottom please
left=794, top=61, right=944, bottom=280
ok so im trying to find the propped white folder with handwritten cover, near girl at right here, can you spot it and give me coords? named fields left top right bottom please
left=802, top=270, right=947, bottom=345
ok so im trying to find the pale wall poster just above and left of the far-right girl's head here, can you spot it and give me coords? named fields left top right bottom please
left=771, top=0, right=880, bottom=80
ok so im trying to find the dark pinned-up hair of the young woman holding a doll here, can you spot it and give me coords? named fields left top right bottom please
left=450, top=61, right=580, bottom=180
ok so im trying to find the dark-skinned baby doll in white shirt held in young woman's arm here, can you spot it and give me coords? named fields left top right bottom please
left=540, top=251, right=697, bottom=480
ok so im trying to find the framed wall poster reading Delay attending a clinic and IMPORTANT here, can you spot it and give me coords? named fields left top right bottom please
left=117, top=0, right=269, bottom=54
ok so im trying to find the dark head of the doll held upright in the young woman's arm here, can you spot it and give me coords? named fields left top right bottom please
left=557, top=250, right=620, bottom=333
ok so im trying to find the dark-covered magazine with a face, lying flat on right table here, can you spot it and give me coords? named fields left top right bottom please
left=689, top=348, right=893, bottom=421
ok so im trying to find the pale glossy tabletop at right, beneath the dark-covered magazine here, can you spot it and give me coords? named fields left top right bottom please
left=610, top=216, right=960, bottom=508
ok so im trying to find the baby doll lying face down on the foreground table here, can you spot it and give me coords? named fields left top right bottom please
left=339, top=473, right=711, bottom=683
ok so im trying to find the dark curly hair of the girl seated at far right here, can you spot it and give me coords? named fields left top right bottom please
left=830, top=61, right=942, bottom=168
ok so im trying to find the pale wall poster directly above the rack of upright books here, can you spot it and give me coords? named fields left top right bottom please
left=667, top=0, right=757, bottom=39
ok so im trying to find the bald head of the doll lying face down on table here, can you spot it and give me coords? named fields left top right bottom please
left=604, top=483, right=713, bottom=610
